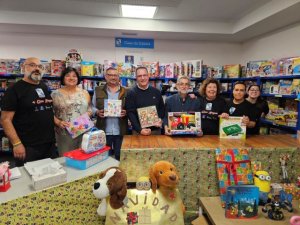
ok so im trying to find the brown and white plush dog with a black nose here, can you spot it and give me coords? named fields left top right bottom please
left=93, top=167, right=127, bottom=216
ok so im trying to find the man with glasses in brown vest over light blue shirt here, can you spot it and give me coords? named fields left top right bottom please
left=92, top=67, right=128, bottom=161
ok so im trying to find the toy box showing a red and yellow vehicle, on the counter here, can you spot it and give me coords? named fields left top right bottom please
left=168, top=112, right=202, bottom=135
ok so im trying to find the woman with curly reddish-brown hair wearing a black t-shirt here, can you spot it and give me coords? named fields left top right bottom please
left=199, top=78, right=227, bottom=134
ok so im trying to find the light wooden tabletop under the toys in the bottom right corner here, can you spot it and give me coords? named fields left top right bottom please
left=200, top=197, right=300, bottom=225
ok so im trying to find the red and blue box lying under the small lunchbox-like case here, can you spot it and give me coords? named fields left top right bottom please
left=64, top=146, right=110, bottom=170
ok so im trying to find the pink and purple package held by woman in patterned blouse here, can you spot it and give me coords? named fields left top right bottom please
left=66, top=113, right=94, bottom=138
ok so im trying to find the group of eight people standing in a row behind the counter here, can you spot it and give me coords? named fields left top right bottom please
left=1, top=57, right=269, bottom=166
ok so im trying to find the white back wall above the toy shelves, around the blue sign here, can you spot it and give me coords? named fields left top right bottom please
left=0, top=33, right=241, bottom=65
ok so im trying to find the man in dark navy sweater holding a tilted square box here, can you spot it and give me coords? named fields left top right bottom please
left=126, top=67, right=164, bottom=135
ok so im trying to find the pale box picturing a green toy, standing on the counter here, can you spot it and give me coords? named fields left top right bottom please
left=219, top=116, right=246, bottom=139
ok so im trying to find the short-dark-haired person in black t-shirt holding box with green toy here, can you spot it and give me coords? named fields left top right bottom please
left=224, top=81, right=257, bottom=134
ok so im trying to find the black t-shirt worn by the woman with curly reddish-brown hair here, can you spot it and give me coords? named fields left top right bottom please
left=200, top=97, right=227, bottom=135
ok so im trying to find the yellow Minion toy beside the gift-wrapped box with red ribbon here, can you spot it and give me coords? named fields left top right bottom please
left=254, top=170, right=271, bottom=205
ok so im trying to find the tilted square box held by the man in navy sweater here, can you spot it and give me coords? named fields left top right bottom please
left=137, top=106, right=160, bottom=128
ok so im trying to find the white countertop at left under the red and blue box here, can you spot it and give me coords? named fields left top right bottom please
left=0, top=157, right=120, bottom=204
